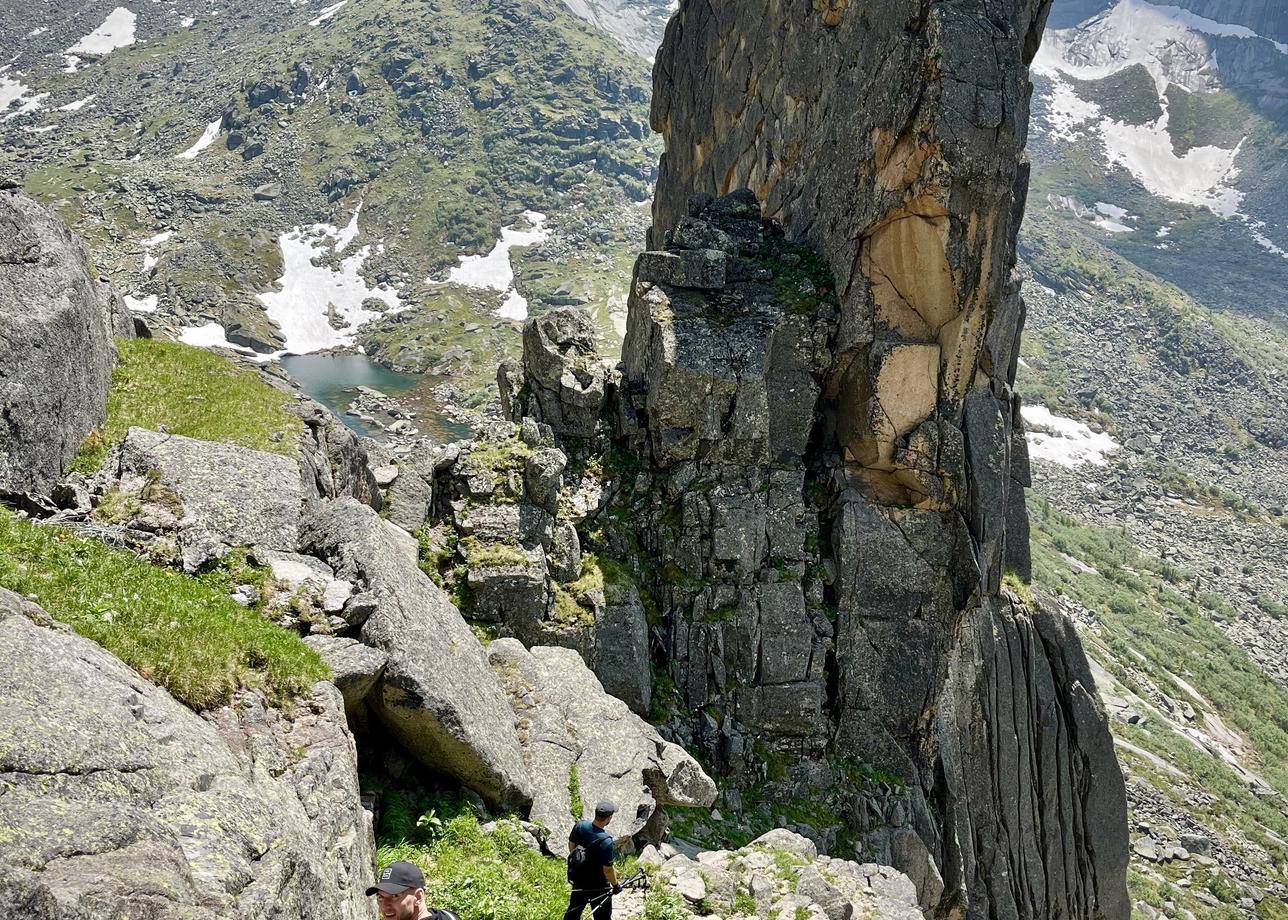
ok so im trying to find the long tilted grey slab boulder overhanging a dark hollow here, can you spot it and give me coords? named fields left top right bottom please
left=301, top=499, right=532, bottom=808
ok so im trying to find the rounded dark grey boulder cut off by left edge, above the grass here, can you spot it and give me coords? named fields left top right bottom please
left=0, top=191, right=115, bottom=494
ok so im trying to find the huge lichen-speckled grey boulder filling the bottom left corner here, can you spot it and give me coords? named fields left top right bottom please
left=0, top=590, right=374, bottom=920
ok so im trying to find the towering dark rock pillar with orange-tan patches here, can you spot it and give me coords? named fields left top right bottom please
left=641, top=0, right=1130, bottom=920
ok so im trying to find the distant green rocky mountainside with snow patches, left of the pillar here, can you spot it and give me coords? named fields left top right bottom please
left=0, top=0, right=656, bottom=376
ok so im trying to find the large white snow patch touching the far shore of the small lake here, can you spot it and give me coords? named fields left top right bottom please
left=259, top=208, right=402, bottom=354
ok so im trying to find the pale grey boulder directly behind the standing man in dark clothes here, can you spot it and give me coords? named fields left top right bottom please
left=487, top=639, right=716, bottom=843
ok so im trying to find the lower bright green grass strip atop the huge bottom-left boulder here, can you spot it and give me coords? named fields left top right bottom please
left=0, top=509, right=328, bottom=710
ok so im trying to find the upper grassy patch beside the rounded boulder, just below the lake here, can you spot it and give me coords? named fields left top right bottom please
left=72, top=339, right=304, bottom=473
